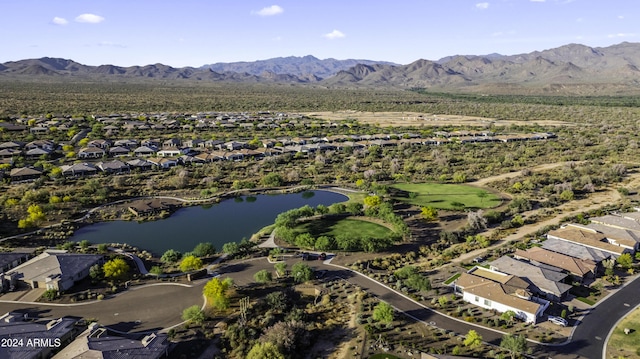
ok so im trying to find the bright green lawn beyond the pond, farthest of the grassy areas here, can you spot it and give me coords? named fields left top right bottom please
left=392, top=183, right=501, bottom=209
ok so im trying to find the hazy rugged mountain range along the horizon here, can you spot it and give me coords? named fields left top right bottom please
left=0, top=42, right=640, bottom=92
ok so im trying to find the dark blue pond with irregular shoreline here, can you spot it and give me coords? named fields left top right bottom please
left=70, top=191, right=347, bottom=255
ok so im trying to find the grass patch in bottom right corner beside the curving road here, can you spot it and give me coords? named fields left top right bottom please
left=607, top=309, right=640, bottom=359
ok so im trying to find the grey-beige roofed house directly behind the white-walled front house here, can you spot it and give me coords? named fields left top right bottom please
left=490, top=256, right=571, bottom=301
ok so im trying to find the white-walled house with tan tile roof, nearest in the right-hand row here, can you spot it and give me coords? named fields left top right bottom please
left=453, top=267, right=549, bottom=324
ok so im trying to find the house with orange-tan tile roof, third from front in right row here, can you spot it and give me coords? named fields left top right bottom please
left=513, top=247, right=596, bottom=282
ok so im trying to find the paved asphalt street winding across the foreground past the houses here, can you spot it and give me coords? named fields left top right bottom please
left=0, top=253, right=640, bottom=359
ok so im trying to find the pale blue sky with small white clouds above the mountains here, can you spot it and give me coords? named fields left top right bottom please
left=0, top=0, right=640, bottom=67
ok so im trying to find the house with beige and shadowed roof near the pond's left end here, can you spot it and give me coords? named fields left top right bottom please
left=8, top=250, right=103, bottom=291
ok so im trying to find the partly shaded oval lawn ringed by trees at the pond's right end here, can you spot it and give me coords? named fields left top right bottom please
left=297, top=218, right=393, bottom=238
